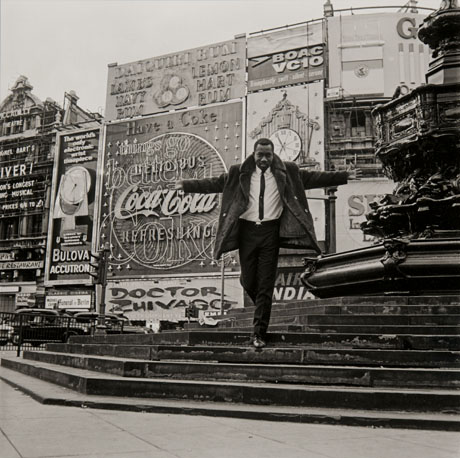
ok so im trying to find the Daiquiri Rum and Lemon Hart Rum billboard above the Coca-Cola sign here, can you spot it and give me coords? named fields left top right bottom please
left=105, top=37, right=246, bottom=120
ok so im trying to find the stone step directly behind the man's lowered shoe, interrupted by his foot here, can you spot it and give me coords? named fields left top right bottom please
left=65, top=330, right=460, bottom=350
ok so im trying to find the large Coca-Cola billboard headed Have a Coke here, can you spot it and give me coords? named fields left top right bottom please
left=100, top=102, right=242, bottom=279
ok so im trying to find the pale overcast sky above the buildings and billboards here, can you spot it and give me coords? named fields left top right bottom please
left=0, top=0, right=441, bottom=114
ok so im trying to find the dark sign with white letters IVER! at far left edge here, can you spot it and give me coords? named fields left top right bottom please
left=0, top=142, right=47, bottom=216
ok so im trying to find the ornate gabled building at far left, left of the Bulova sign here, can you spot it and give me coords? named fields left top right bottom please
left=0, top=76, right=100, bottom=311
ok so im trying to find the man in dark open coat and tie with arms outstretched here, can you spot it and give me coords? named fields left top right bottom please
left=175, top=138, right=361, bottom=348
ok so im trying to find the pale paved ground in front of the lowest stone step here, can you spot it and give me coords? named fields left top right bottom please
left=0, top=380, right=460, bottom=458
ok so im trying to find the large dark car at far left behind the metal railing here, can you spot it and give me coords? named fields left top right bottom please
left=12, top=308, right=88, bottom=347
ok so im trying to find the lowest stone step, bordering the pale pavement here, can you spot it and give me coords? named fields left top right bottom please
left=0, top=366, right=460, bottom=431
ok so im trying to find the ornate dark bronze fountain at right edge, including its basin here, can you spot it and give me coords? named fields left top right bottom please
left=303, top=0, right=460, bottom=298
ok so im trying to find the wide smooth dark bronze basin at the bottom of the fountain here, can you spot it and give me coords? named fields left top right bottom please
left=302, top=231, right=460, bottom=298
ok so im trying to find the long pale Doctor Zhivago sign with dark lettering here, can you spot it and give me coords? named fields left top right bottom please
left=106, top=276, right=243, bottom=321
